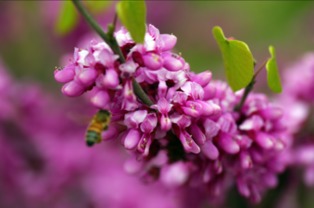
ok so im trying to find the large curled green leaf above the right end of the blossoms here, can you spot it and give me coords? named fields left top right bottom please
left=212, top=26, right=254, bottom=91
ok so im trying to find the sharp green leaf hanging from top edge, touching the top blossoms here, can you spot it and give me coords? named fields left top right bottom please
left=116, top=0, right=146, bottom=43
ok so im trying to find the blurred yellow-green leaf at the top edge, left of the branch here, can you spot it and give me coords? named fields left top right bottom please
left=55, top=1, right=78, bottom=35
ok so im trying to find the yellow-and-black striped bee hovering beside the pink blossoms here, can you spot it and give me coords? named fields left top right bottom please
left=85, top=110, right=111, bottom=147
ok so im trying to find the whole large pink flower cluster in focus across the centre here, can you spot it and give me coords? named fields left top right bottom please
left=55, top=25, right=291, bottom=201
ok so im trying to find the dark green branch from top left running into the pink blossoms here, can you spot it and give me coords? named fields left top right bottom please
left=72, top=0, right=153, bottom=106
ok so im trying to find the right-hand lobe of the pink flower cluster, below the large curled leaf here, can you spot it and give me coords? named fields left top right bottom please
left=217, top=89, right=292, bottom=202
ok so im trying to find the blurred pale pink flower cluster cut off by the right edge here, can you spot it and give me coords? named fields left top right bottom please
left=277, top=53, right=314, bottom=186
